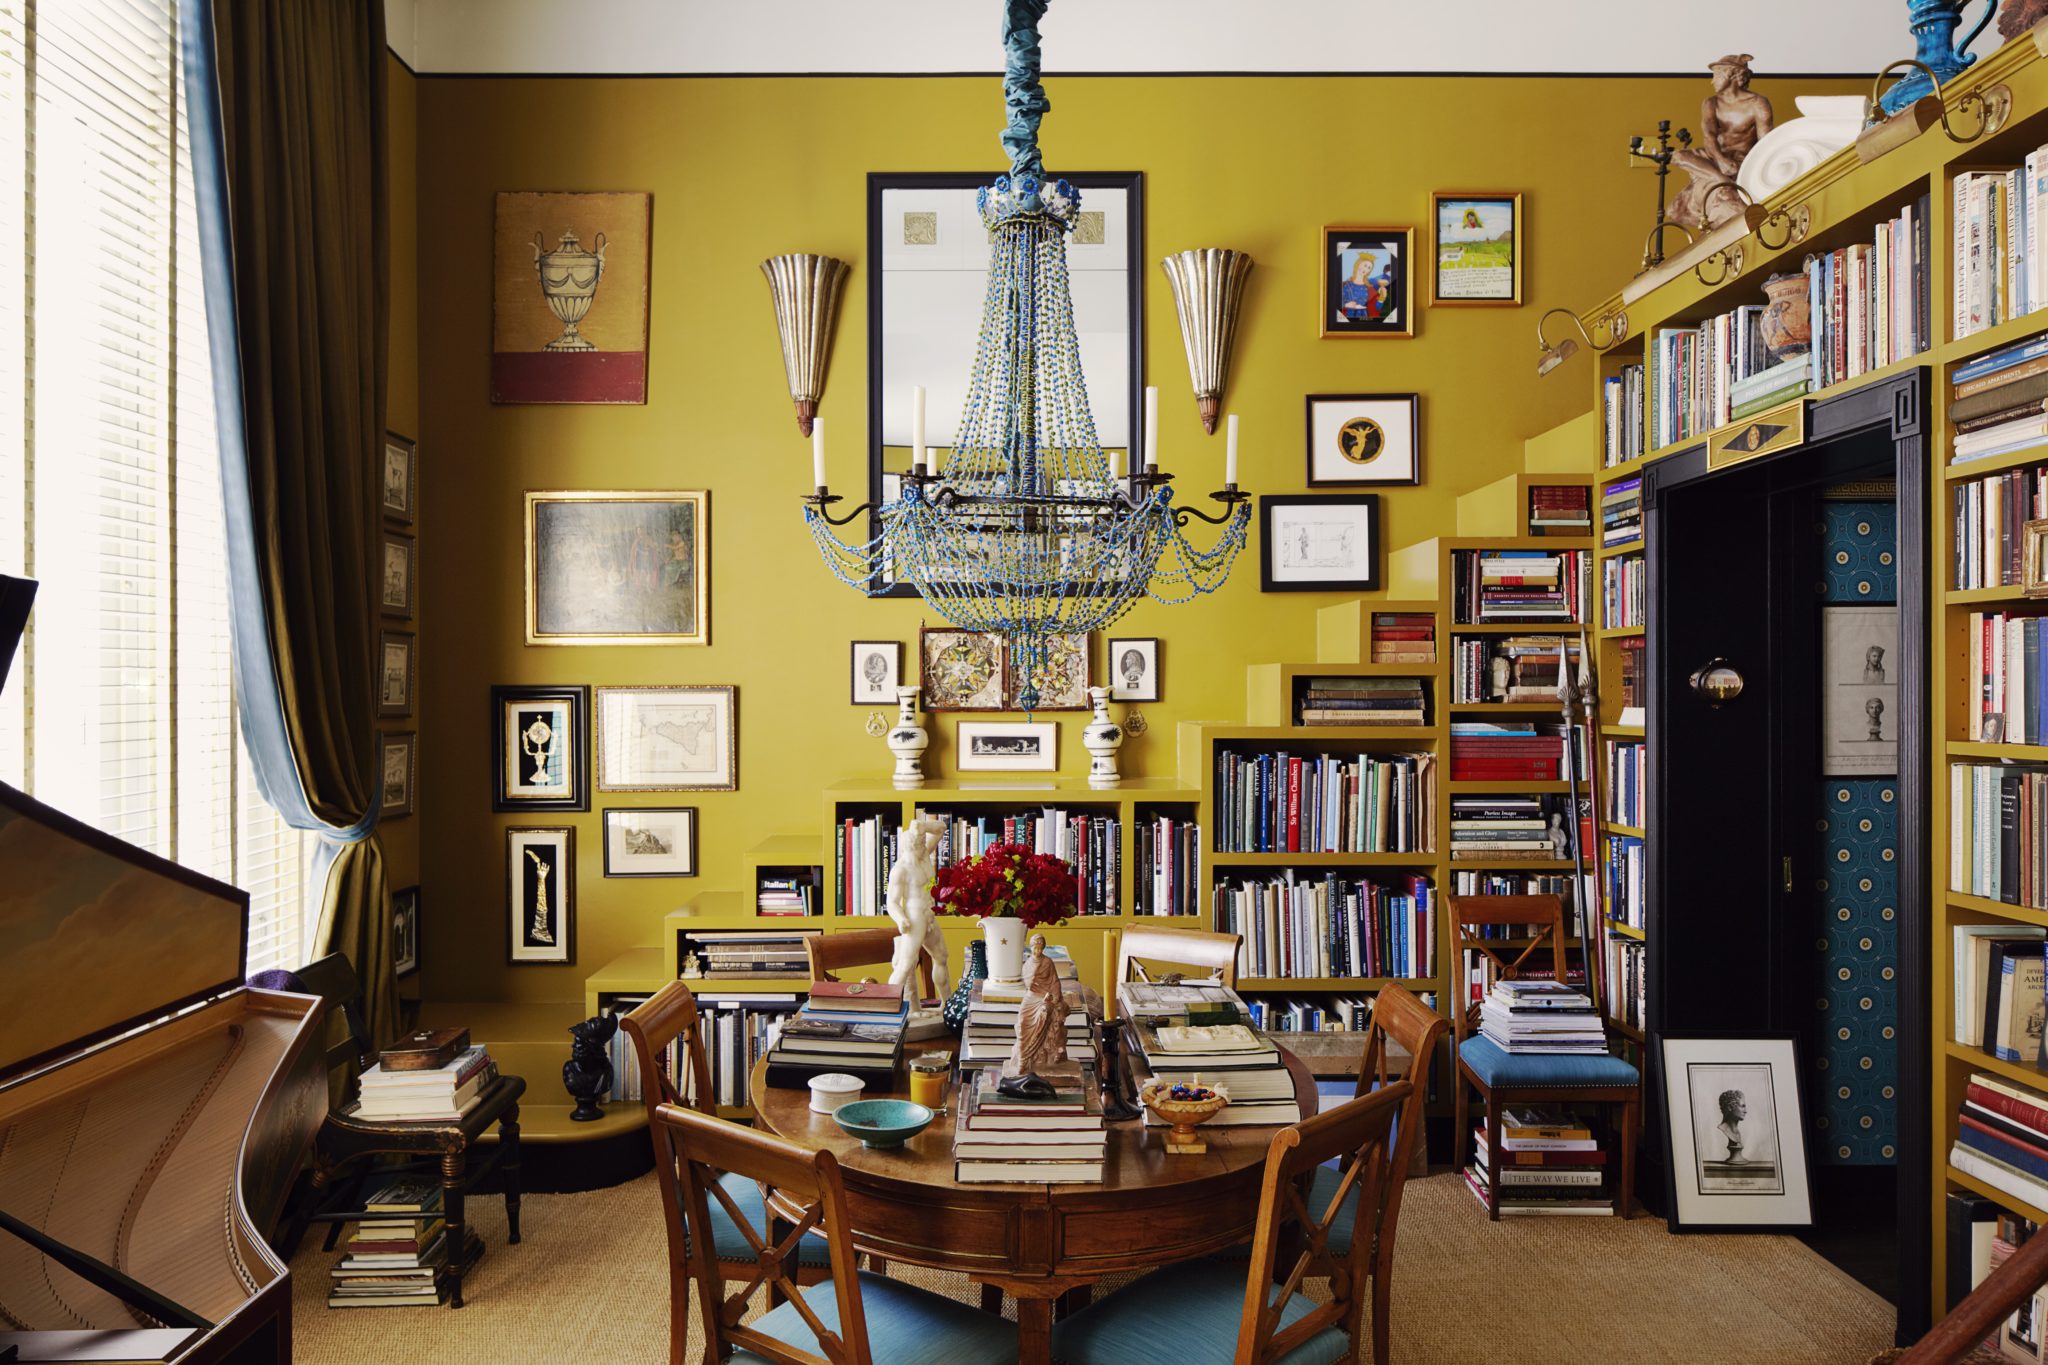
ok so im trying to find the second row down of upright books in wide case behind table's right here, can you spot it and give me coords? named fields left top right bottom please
left=1212, top=872, right=1436, bottom=978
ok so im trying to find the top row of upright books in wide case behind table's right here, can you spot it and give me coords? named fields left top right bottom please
left=1217, top=751, right=1436, bottom=853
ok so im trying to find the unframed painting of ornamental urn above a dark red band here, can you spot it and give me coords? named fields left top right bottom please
left=492, top=190, right=653, bottom=403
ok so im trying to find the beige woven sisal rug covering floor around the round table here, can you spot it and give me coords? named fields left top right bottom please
left=291, top=1175, right=1892, bottom=1365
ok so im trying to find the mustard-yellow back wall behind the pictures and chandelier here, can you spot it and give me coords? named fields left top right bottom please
left=411, top=78, right=1853, bottom=1001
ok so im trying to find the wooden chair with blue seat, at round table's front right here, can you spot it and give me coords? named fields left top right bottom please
left=1053, top=1081, right=1415, bottom=1365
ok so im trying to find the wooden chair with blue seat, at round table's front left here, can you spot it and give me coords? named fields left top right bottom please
left=653, top=1103, right=1018, bottom=1365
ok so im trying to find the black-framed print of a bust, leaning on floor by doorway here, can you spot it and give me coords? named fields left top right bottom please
left=1655, top=1033, right=1812, bottom=1232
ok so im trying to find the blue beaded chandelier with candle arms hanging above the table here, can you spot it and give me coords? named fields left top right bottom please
left=803, top=0, right=1251, bottom=710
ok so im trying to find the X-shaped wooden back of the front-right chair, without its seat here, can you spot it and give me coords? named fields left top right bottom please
left=1235, top=1081, right=1415, bottom=1365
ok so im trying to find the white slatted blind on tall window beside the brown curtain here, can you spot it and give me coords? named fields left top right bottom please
left=0, top=0, right=311, bottom=972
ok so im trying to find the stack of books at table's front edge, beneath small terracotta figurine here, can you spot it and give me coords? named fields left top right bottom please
left=952, top=1062, right=1110, bottom=1185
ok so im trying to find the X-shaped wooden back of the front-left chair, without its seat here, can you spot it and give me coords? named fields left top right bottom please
left=653, top=1105, right=874, bottom=1365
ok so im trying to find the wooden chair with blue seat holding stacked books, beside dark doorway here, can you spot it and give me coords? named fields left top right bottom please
left=1450, top=896, right=1642, bottom=1220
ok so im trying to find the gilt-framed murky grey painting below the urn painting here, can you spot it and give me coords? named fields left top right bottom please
left=526, top=489, right=711, bottom=645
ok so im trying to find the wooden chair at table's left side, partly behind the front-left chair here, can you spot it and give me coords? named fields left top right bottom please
left=618, top=980, right=831, bottom=1365
